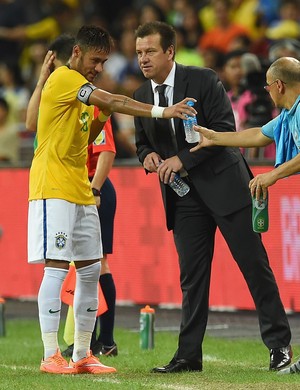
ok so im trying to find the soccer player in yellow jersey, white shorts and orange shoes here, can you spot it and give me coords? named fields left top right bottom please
left=28, top=26, right=196, bottom=374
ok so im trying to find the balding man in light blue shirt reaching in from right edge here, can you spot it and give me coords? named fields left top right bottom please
left=191, top=57, right=300, bottom=374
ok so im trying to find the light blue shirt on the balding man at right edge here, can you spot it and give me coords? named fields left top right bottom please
left=261, top=96, right=300, bottom=167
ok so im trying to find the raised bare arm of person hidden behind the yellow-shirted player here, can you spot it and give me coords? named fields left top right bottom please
left=25, top=50, right=55, bottom=131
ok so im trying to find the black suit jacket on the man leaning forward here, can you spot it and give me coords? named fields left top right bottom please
left=134, top=64, right=252, bottom=229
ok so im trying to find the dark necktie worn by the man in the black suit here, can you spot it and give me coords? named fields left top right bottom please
left=156, top=84, right=177, bottom=157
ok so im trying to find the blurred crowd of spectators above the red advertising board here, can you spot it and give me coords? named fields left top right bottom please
left=0, top=0, right=300, bottom=166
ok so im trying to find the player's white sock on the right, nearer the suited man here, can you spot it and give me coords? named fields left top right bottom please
left=72, top=262, right=101, bottom=362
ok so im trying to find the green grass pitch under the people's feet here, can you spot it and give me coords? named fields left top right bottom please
left=0, top=320, right=300, bottom=390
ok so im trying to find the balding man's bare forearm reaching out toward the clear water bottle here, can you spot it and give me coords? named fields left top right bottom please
left=191, top=126, right=273, bottom=152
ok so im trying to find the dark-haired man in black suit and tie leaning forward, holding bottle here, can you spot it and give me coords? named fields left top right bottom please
left=134, top=22, right=292, bottom=373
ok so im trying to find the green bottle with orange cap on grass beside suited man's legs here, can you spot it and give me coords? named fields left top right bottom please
left=140, top=305, right=155, bottom=349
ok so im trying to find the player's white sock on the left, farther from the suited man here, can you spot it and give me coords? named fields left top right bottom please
left=38, top=267, right=68, bottom=359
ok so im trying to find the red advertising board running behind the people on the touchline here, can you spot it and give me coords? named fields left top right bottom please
left=0, top=166, right=300, bottom=312
